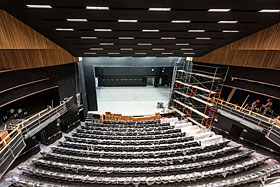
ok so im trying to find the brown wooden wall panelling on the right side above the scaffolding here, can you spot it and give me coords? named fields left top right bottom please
left=193, top=23, right=280, bottom=69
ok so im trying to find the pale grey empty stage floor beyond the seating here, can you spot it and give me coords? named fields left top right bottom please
left=94, top=87, right=170, bottom=115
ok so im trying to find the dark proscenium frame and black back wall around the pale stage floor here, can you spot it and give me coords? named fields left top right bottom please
left=79, top=57, right=179, bottom=111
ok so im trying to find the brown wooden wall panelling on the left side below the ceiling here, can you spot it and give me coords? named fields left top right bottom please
left=0, top=10, right=78, bottom=71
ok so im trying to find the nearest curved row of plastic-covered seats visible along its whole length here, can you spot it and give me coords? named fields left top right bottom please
left=18, top=158, right=270, bottom=186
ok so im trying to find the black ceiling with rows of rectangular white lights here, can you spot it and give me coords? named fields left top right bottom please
left=0, top=0, right=280, bottom=57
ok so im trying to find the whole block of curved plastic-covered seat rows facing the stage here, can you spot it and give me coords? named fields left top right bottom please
left=7, top=118, right=279, bottom=187
